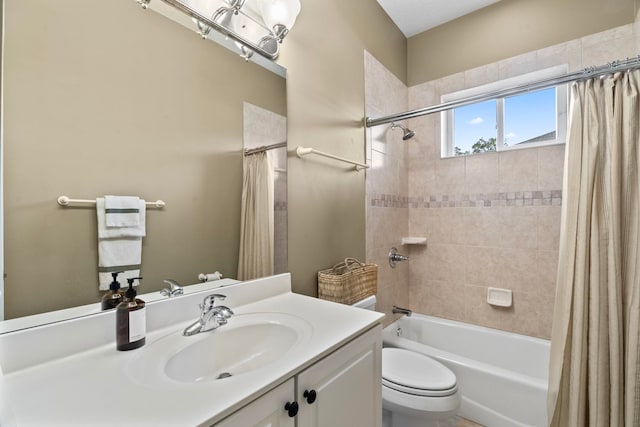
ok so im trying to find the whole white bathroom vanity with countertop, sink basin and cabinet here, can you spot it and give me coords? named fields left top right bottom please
left=0, top=274, right=383, bottom=427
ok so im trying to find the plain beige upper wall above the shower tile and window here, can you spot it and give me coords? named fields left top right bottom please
left=408, top=0, right=637, bottom=86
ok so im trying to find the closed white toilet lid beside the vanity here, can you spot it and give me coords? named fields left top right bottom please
left=382, top=348, right=457, bottom=396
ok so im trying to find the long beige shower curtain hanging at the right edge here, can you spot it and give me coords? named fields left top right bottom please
left=548, top=71, right=640, bottom=427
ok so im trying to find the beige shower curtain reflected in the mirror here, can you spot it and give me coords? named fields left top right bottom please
left=237, top=151, right=274, bottom=280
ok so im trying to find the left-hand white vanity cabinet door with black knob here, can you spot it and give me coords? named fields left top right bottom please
left=214, top=378, right=295, bottom=427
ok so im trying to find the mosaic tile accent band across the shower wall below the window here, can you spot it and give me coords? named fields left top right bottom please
left=370, top=190, right=562, bottom=208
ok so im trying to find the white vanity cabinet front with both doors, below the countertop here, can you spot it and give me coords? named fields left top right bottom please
left=215, top=325, right=382, bottom=427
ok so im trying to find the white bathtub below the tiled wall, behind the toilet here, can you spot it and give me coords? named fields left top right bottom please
left=383, top=313, right=549, bottom=427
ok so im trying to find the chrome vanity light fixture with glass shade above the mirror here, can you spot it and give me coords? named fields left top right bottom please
left=136, top=0, right=300, bottom=60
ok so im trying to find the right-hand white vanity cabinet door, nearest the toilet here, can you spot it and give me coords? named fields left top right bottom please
left=296, top=326, right=382, bottom=427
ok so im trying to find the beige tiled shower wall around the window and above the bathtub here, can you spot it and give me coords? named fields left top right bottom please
left=366, top=24, right=640, bottom=338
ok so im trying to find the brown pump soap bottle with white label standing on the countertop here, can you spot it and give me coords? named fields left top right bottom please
left=116, top=277, right=147, bottom=351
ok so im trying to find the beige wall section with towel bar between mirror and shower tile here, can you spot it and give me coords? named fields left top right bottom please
left=279, top=0, right=406, bottom=295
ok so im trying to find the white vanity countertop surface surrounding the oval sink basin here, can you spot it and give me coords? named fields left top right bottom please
left=0, top=275, right=384, bottom=427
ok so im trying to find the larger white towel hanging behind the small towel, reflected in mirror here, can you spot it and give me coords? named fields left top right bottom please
left=96, top=198, right=146, bottom=291
